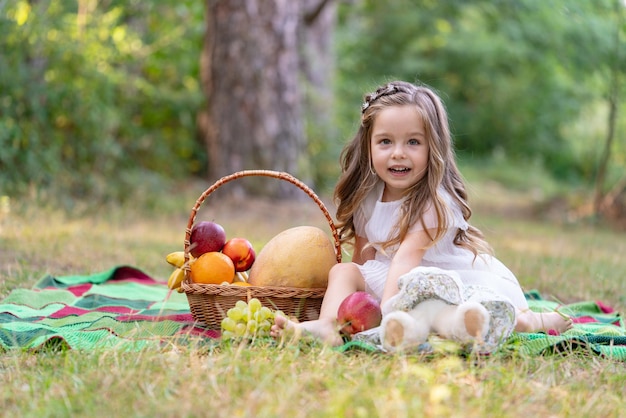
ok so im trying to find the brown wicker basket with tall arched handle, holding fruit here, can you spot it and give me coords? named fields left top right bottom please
left=181, top=170, right=341, bottom=329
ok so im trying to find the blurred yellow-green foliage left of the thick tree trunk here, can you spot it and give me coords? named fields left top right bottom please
left=0, top=0, right=205, bottom=206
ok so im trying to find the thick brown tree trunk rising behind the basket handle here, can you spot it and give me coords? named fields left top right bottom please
left=199, top=0, right=306, bottom=197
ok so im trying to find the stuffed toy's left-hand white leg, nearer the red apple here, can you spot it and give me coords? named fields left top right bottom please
left=380, top=300, right=449, bottom=351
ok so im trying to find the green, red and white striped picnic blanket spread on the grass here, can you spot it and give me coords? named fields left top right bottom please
left=0, top=266, right=626, bottom=360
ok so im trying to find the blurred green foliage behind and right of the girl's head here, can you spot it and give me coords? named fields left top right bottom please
left=337, top=0, right=626, bottom=186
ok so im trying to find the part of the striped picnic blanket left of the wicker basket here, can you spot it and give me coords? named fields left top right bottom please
left=0, top=266, right=219, bottom=350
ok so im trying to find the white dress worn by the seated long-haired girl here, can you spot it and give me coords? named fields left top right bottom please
left=354, top=182, right=528, bottom=351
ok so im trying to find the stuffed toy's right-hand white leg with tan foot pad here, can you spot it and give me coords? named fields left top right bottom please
left=432, top=302, right=490, bottom=343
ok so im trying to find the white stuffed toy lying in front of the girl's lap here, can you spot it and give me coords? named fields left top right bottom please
left=355, top=267, right=515, bottom=353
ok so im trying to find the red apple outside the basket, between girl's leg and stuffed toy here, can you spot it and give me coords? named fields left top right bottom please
left=337, top=292, right=383, bottom=335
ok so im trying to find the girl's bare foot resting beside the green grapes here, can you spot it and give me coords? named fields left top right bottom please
left=270, top=315, right=343, bottom=347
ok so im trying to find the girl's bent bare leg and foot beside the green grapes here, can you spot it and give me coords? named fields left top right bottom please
left=270, top=263, right=365, bottom=346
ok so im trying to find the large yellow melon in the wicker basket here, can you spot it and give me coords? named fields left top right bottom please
left=248, top=226, right=337, bottom=288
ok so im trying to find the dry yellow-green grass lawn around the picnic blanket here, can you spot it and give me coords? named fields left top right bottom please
left=0, top=175, right=626, bottom=417
